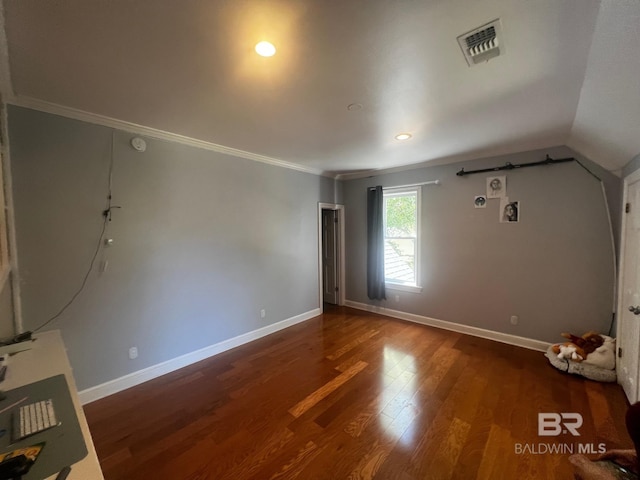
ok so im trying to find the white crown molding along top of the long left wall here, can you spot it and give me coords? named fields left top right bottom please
left=8, top=96, right=335, bottom=178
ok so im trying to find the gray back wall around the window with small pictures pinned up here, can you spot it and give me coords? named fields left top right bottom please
left=343, top=147, right=620, bottom=342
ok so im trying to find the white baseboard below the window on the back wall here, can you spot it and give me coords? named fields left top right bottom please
left=345, top=300, right=551, bottom=352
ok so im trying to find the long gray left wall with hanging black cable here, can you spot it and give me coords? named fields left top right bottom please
left=9, top=107, right=335, bottom=389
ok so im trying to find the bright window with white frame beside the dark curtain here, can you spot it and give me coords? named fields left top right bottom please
left=383, top=187, right=420, bottom=291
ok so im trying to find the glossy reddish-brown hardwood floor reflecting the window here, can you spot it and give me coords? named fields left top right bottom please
left=85, top=307, right=632, bottom=480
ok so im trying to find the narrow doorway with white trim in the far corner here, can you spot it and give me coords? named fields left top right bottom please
left=318, top=203, right=345, bottom=312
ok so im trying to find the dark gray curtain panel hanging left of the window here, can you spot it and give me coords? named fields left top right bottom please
left=367, top=185, right=387, bottom=300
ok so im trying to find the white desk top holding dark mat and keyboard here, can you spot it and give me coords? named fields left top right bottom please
left=0, top=330, right=104, bottom=480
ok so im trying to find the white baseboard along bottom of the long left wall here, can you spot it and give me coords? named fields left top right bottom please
left=79, top=308, right=321, bottom=405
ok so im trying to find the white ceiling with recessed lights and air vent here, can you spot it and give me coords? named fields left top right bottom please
left=0, top=0, right=640, bottom=174
